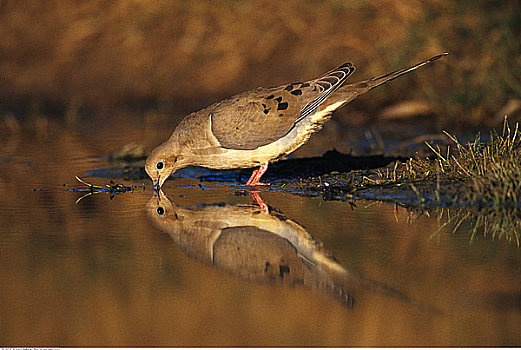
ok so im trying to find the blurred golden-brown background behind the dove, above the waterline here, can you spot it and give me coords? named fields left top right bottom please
left=0, top=0, right=521, bottom=128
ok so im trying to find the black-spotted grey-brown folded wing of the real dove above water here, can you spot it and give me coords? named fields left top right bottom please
left=210, top=63, right=354, bottom=149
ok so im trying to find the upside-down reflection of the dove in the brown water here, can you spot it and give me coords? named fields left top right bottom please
left=147, top=191, right=422, bottom=308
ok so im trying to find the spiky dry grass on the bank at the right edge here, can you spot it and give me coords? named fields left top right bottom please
left=390, top=119, right=521, bottom=209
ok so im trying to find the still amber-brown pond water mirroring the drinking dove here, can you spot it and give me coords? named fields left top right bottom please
left=0, top=118, right=521, bottom=346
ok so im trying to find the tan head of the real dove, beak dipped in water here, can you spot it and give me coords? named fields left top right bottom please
left=145, top=142, right=183, bottom=190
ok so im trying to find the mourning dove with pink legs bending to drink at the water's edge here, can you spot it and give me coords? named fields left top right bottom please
left=145, top=53, right=448, bottom=189
